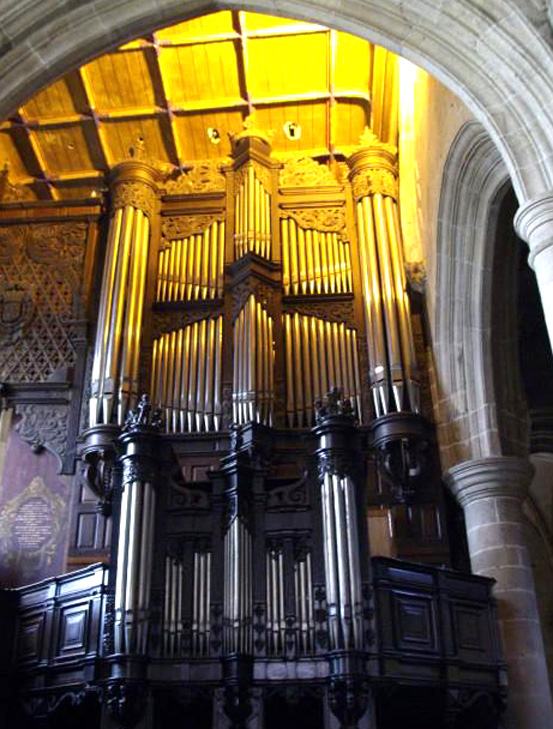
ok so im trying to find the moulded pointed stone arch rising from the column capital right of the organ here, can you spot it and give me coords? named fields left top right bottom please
left=434, top=121, right=525, bottom=468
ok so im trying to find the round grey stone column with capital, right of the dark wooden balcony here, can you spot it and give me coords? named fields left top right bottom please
left=446, top=456, right=553, bottom=729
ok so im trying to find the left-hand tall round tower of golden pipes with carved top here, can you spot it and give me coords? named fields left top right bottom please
left=89, top=161, right=157, bottom=426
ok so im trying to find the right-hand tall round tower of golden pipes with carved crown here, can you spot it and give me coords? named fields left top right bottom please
left=349, top=139, right=420, bottom=417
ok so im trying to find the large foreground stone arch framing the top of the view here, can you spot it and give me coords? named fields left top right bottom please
left=0, top=0, right=553, bottom=202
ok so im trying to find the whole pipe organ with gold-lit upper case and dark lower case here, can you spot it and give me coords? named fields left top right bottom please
left=73, top=124, right=458, bottom=729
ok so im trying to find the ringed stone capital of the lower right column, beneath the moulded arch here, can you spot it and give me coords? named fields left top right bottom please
left=444, top=456, right=534, bottom=508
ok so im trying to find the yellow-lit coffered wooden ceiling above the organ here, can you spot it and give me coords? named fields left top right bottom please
left=0, top=11, right=397, bottom=200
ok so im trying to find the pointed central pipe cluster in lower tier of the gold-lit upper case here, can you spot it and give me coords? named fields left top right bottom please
left=232, top=294, right=275, bottom=425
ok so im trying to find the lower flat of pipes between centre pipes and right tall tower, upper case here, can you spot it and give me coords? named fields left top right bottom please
left=283, top=313, right=362, bottom=428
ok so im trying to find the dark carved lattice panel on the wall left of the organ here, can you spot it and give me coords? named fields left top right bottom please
left=0, top=223, right=88, bottom=382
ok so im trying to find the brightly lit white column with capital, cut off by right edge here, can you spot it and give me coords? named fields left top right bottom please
left=514, top=193, right=553, bottom=348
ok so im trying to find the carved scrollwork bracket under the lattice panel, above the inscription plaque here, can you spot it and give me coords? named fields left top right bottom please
left=15, top=404, right=68, bottom=460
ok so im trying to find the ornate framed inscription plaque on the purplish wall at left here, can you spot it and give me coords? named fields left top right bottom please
left=0, top=476, right=65, bottom=573
